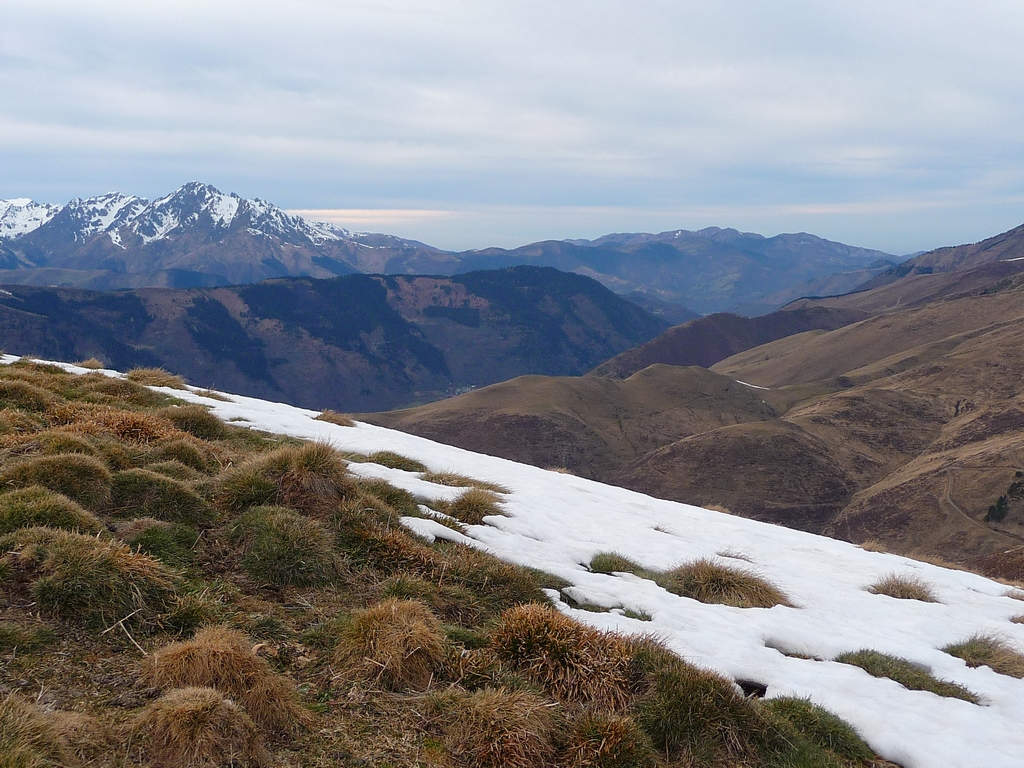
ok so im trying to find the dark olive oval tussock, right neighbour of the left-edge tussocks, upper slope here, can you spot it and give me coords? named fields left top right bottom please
left=111, top=469, right=216, bottom=527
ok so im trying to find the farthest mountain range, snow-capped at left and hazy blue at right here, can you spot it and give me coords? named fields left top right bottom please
left=6, top=181, right=899, bottom=313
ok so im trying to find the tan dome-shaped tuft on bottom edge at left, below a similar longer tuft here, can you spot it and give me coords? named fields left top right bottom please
left=132, top=687, right=271, bottom=768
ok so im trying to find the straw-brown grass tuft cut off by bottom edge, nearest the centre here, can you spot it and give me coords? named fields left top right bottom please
left=434, top=688, right=559, bottom=768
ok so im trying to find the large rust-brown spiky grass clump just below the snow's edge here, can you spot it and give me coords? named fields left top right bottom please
left=490, top=604, right=637, bottom=710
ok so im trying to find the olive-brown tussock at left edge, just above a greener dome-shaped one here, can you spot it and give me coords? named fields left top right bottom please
left=0, top=454, right=111, bottom=509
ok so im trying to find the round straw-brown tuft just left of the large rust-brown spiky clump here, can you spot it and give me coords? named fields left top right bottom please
left=334, top=598, right=447, bottom=691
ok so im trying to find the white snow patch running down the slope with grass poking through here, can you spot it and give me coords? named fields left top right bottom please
left=8, top=356, right=1024, bottom=768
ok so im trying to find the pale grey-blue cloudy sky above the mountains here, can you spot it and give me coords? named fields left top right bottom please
left=0, top=0, right=1024, bottom=253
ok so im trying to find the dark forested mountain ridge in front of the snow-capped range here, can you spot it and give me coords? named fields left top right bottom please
left=0, top=266, right=668, bottom=411
